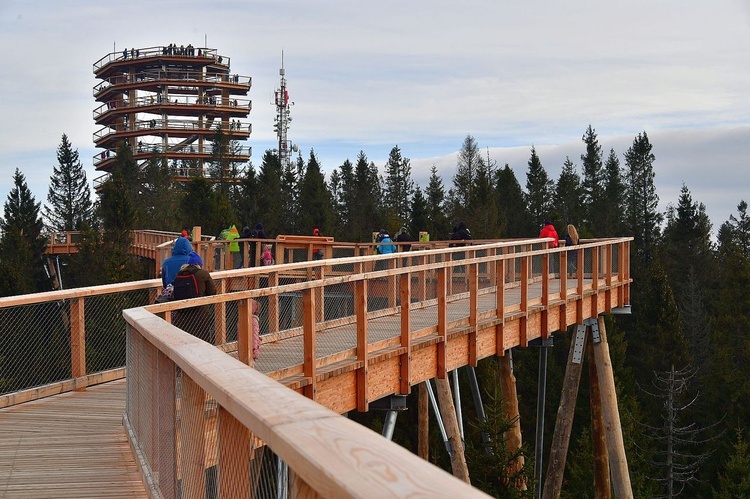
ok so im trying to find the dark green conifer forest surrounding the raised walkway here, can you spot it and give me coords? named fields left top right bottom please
left=0, top=125, right=750, bottom=498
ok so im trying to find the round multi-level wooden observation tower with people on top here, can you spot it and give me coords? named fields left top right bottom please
left=93, top=44, right=252, bottom=188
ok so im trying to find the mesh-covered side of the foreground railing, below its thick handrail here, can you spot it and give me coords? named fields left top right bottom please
left=126, top=332, right=298, bottom=499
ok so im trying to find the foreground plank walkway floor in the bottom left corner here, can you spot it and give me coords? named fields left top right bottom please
left=0, top=380, right=148, bottom=499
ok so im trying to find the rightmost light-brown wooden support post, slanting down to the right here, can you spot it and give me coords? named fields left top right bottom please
left=594, top=318, right=633, bottom=498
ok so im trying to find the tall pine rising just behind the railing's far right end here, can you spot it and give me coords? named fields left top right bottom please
left=625, top=132, right=663, bottom=263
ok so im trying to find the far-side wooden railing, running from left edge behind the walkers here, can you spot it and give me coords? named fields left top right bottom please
left=0, top=239, right=630, bottom=407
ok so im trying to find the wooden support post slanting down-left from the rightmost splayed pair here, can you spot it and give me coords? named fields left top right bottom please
left=542, top=324, right=587, bottom=498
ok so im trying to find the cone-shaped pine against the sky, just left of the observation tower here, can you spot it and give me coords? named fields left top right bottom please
left=44, top=134, right=93, bottom=232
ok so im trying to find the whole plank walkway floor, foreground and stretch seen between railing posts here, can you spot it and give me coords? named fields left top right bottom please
left=0, top=279, right=608, bottom=498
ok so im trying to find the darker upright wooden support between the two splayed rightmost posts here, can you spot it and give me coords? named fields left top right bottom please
left=586, top=329, right=612, bottom=499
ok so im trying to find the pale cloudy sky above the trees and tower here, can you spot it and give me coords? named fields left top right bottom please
left=0, top=0, right=750, bottom=235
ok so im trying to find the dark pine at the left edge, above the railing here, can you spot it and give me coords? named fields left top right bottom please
left=0, top=168, right=51, bottom=296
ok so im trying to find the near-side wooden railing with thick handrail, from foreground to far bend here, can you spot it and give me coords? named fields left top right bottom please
left=124, top=238, right=630, bottom=497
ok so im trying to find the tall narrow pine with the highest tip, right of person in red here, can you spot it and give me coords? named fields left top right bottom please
left=581, top=125, right=605, bottom=234
